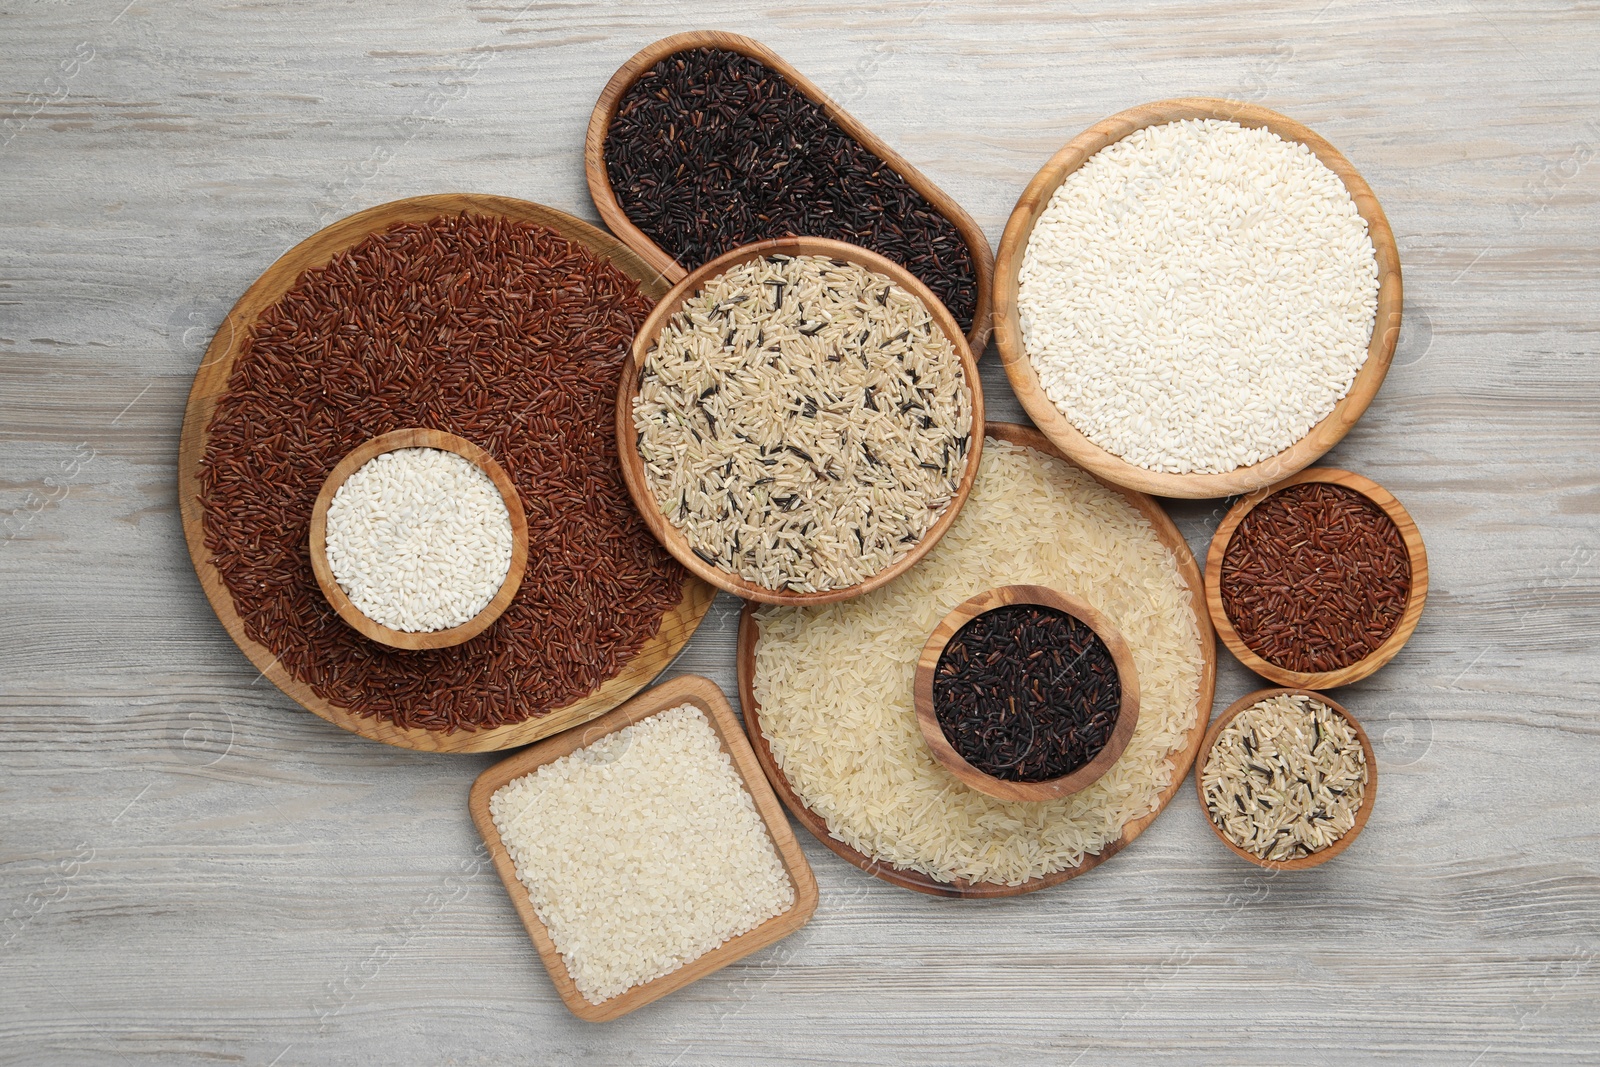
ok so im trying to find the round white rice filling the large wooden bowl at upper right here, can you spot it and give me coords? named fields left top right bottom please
left=1018, top=118, right=1378, bottom=474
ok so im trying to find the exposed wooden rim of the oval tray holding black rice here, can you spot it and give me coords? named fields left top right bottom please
left=584, top=30, right=995, bottom=351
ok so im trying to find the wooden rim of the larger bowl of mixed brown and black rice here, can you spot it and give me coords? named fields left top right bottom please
left=616, top=237, right=984, bottom=605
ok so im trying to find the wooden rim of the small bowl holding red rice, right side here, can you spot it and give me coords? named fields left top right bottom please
left=1205, top=467, right=1427, bottom=691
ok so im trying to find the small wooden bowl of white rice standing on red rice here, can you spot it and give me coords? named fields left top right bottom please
left=310, top=427, right=528, bottom=649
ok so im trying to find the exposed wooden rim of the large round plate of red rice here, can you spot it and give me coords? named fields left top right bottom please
left=178, top=194, right=717, bottom=752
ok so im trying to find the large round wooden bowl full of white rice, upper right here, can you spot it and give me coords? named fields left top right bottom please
left=995, top=99, right=1402, bottom=499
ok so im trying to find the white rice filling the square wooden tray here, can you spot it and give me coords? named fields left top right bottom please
left=490, top=704, right=795, bottom=1005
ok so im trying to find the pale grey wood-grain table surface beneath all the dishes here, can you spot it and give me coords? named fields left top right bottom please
left=0, top=0, right=1600, bottom=1064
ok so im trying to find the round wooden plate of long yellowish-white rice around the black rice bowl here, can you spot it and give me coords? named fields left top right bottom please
left=739, top=424, right=1216, bottom=897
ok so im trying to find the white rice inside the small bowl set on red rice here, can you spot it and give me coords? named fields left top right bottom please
left=326, top=448, right=512, bottom=632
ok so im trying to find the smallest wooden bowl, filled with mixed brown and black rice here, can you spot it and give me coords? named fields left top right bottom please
left=1195, top=689, right=1378, bottom=870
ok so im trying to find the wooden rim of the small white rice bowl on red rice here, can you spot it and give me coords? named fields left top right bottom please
left=310, top=427, right=528, bottom=648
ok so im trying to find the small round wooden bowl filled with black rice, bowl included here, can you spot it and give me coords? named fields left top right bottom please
left=914, top=585, right=1139, bottom=801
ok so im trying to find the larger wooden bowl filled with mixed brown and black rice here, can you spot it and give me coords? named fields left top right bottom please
left=616, top=237, right=984, bottom=603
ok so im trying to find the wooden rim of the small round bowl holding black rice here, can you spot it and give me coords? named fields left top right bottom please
left=912, top=584, right=1139, bottom=801
